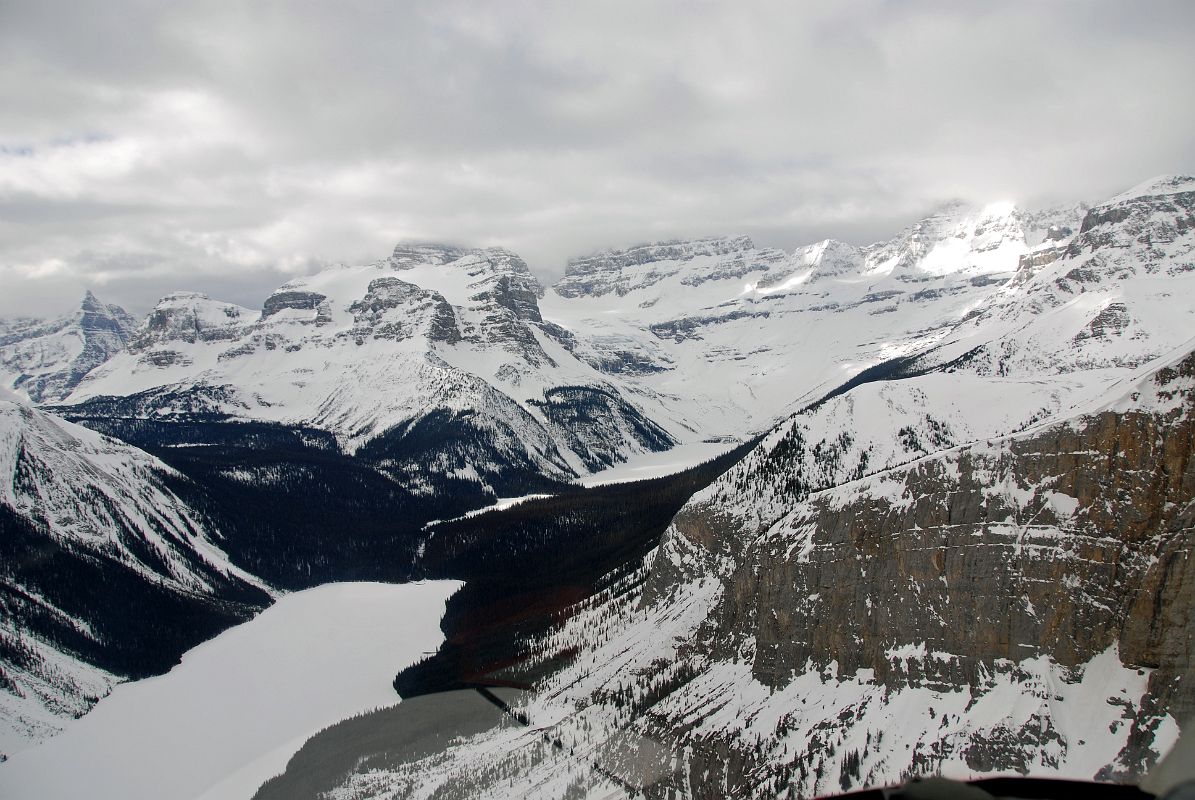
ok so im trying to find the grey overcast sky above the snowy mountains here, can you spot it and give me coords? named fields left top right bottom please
left=0, top=0, right=1195, bottom=316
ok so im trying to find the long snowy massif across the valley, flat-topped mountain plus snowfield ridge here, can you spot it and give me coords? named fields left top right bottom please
left=48, top=196, right=1079, bottom=494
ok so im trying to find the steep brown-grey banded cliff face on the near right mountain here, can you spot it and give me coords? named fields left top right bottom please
left=693, top=370, right=1195, bottom=688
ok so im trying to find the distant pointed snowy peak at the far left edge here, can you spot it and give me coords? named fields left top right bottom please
left=0, top=292, right=136, bottom=403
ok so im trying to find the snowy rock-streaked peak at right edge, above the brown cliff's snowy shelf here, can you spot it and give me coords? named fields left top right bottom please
left=903, top=176, right=1195, bottom=377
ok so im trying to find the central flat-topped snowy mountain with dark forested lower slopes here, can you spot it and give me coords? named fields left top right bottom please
left=69, top=246, right=674, bottom=486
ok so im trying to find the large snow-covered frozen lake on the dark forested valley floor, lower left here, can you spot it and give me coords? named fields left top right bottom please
left=0, top=581, right=460, bottom=800
